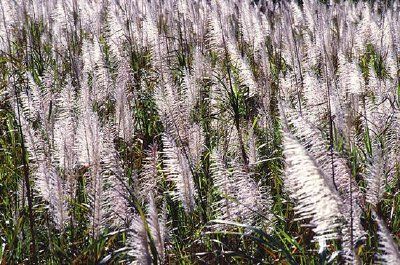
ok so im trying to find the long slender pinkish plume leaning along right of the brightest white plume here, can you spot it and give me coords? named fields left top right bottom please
left=281, top=103, right=365, bottom=260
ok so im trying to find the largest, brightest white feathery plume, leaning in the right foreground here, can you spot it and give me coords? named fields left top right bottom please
left=283, top=132, right=343, bottom=240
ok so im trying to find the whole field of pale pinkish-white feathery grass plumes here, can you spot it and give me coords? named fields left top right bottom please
left=0, top=0, right=400, bottom=264
